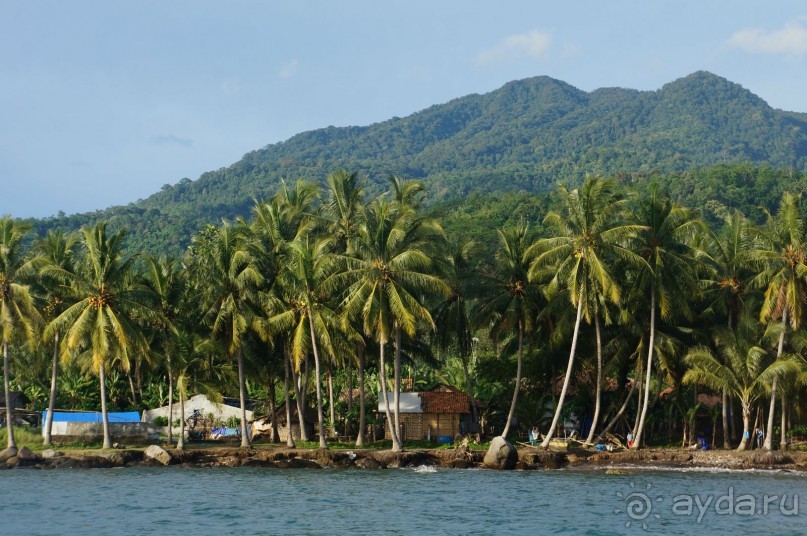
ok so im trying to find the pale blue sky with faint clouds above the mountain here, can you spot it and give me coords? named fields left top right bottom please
left=0, top=0, right=807, bottom=217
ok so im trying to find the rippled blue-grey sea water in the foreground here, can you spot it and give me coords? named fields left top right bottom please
left=0, top=467, right=807, bottom=535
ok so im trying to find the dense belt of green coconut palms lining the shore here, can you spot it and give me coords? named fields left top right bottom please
left=0, top=170, right=807, bottom=451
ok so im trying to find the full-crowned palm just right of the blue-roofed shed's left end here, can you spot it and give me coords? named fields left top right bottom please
left=43, top=223, right=156, bottom=448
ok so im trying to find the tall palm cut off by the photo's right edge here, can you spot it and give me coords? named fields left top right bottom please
left=751, top=193, right=807, bottom=450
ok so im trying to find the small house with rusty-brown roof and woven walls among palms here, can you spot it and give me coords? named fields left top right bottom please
left=378, top=383, right=478, bottom=441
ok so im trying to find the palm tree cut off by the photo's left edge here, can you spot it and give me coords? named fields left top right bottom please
left=0, top=216, right=39, bottom=455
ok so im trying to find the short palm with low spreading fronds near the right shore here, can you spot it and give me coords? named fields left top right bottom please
left=683, top=319, right=799, bottom=451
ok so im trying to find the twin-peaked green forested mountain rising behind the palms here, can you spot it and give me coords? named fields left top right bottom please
left=30, top=72, right=807, bottom=253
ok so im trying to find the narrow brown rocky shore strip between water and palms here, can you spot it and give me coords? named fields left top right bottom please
left=0, top=445, right=807, bottom=474
